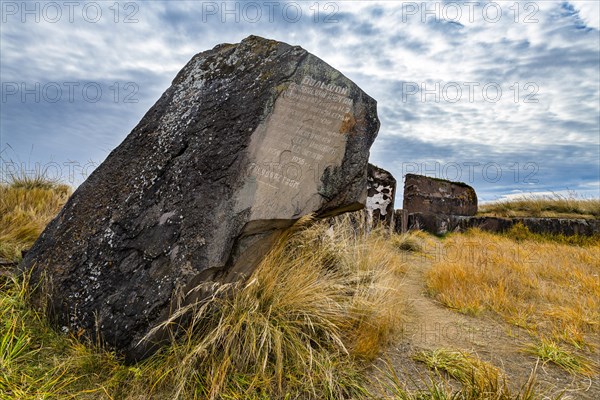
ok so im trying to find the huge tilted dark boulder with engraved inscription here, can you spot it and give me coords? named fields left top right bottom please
left=20, top=36, right=379, bottom=362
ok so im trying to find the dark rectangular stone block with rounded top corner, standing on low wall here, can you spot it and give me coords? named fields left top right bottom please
left=403, top=174, right=477, bottom=216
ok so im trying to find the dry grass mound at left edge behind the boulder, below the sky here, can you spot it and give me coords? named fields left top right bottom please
left=0, top=178, right=71, bottom=261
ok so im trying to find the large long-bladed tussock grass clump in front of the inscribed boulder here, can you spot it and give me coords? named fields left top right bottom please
left=145, top=219, right=401, bottom=399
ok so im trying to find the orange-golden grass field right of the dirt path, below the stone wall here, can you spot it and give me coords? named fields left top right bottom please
left=427, top=230, right=600, bottom=376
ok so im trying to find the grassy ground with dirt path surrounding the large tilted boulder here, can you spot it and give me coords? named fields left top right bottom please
left=0, top=182, right=600, bottom=399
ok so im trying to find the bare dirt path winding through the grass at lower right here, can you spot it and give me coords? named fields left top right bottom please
left=380, top=254, right=600, bottom=400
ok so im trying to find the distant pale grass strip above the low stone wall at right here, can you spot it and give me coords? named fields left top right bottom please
left=479, top=194, right=600, bottom=218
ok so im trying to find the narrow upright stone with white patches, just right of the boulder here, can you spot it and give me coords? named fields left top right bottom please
left=366, top=164, right=396, bottom=226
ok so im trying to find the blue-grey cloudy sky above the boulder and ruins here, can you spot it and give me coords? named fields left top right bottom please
left=0, top=0, right=600, bottom=206
